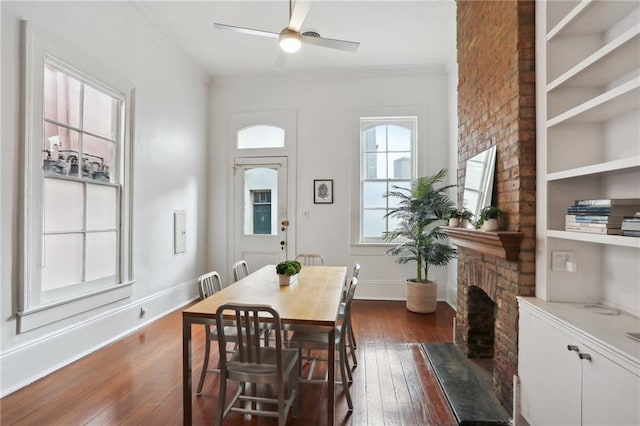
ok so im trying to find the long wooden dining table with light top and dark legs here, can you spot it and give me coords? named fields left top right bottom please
left=182, top=265, right=347, bottom=425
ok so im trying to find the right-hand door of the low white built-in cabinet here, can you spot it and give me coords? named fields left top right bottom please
left=581, top=346, right=640, bottom=425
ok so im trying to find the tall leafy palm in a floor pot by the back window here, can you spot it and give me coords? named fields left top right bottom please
left=384, top=169, right=456, bottom=313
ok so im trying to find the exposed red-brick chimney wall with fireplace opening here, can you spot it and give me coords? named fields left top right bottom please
left=456, top=0, right=536, bottom=410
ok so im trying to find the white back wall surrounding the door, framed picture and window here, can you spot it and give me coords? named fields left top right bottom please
left=209, top=67, right=455, bottom=300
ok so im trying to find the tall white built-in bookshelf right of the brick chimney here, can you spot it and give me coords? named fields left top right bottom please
left=536, top=0, right=640, bottom=310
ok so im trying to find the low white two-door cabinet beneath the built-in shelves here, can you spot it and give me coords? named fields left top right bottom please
left=518, top=298, right=640, bottom=425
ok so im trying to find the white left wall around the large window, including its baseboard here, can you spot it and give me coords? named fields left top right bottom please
left=0, top=2, right=210, bottom=395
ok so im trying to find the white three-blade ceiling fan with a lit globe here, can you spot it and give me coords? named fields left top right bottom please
left=213, top=0, right=360, bottom=53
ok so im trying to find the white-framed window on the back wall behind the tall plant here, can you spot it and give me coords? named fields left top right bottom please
left=360, top=117, right=417, bottom=243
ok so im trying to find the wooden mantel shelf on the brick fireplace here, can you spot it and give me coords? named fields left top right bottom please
left=443, top=227, right=523, bottom=261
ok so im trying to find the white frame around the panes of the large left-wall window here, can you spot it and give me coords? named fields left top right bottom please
left=17, top=21, right=133, bottom=333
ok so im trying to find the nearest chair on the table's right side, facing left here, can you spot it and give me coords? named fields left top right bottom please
left=289, top=278, right=358, bottom=411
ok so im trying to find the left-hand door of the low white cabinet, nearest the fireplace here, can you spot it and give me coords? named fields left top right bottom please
left=518, top=311, right=581, bottom=425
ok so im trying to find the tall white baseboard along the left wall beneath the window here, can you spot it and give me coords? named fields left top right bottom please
left=0, top=280, right=198, bottom=397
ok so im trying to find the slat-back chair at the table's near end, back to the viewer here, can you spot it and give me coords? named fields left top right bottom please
left=216, top=303, right=300, bottom=426
